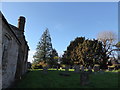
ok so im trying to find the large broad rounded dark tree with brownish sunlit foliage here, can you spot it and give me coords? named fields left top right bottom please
left=62, top=37, right=107, bottom=67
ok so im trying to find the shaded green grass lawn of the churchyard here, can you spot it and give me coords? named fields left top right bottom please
left=15, top=70, right=120, bottom=88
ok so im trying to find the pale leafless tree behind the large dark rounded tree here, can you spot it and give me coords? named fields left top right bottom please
left=97, top=31, right=117, bottom=56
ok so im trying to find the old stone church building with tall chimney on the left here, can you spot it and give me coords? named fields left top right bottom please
left=0, top=12, right=29, bottom=88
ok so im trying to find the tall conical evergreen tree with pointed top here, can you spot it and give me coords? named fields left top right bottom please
left=33, top=29, right=52, bottom=63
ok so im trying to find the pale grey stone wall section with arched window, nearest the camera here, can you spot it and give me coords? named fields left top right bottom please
left=2, top=18, right=20, bottom=88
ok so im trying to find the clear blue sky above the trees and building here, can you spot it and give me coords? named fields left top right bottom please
left=1, top=2, right=118, bottom=61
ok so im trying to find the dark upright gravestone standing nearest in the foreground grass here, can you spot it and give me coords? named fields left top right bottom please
left=80, top=71, right=89, bottom=86
